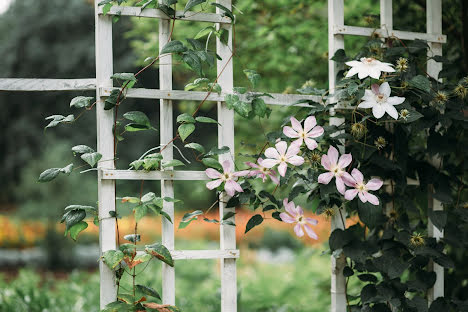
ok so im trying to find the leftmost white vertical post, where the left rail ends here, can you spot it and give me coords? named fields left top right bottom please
left=94, top=0, right=117, bottom=309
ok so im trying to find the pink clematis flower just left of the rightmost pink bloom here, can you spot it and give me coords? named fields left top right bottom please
left=318, top=146, right=353, bottom=195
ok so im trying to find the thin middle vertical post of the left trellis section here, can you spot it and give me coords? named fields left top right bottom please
left=159, top=10, right=175, bottom=305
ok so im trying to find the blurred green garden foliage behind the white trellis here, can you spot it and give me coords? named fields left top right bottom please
left=0, top=0, right=468, bottom=311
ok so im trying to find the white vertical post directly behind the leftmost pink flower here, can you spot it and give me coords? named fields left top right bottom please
left=216, top=0, right=237, bottom=312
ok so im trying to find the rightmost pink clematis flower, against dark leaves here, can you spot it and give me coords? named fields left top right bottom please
left=343, top=168, right=383, bottom=206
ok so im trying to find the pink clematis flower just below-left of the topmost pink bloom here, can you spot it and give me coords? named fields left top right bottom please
left=262, top=141, right=304, bottom=177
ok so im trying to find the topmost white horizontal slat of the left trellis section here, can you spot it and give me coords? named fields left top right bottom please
left=99, top=6, right=231, bottom=23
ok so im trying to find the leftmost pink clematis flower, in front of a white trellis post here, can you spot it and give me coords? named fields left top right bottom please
left=205, top=160, right=249, bottom=196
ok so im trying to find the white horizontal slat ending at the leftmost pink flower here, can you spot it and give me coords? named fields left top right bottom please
left=100, top=169, right=210, bottom=181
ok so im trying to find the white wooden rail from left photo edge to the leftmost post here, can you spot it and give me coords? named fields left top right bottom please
left=0, top=78, right=96, bottom=91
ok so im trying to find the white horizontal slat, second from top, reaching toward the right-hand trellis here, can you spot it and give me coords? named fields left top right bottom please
left=101, top=88, right=321, bottom=107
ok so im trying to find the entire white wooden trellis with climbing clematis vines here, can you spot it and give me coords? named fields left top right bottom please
left=0, top=0, right=446, bottom=312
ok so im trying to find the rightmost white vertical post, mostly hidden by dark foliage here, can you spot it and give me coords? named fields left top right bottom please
left=426, top=0, right=444, bottom=303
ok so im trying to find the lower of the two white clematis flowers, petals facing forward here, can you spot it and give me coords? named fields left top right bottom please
left=358, top=82, right=405, bottom=119
